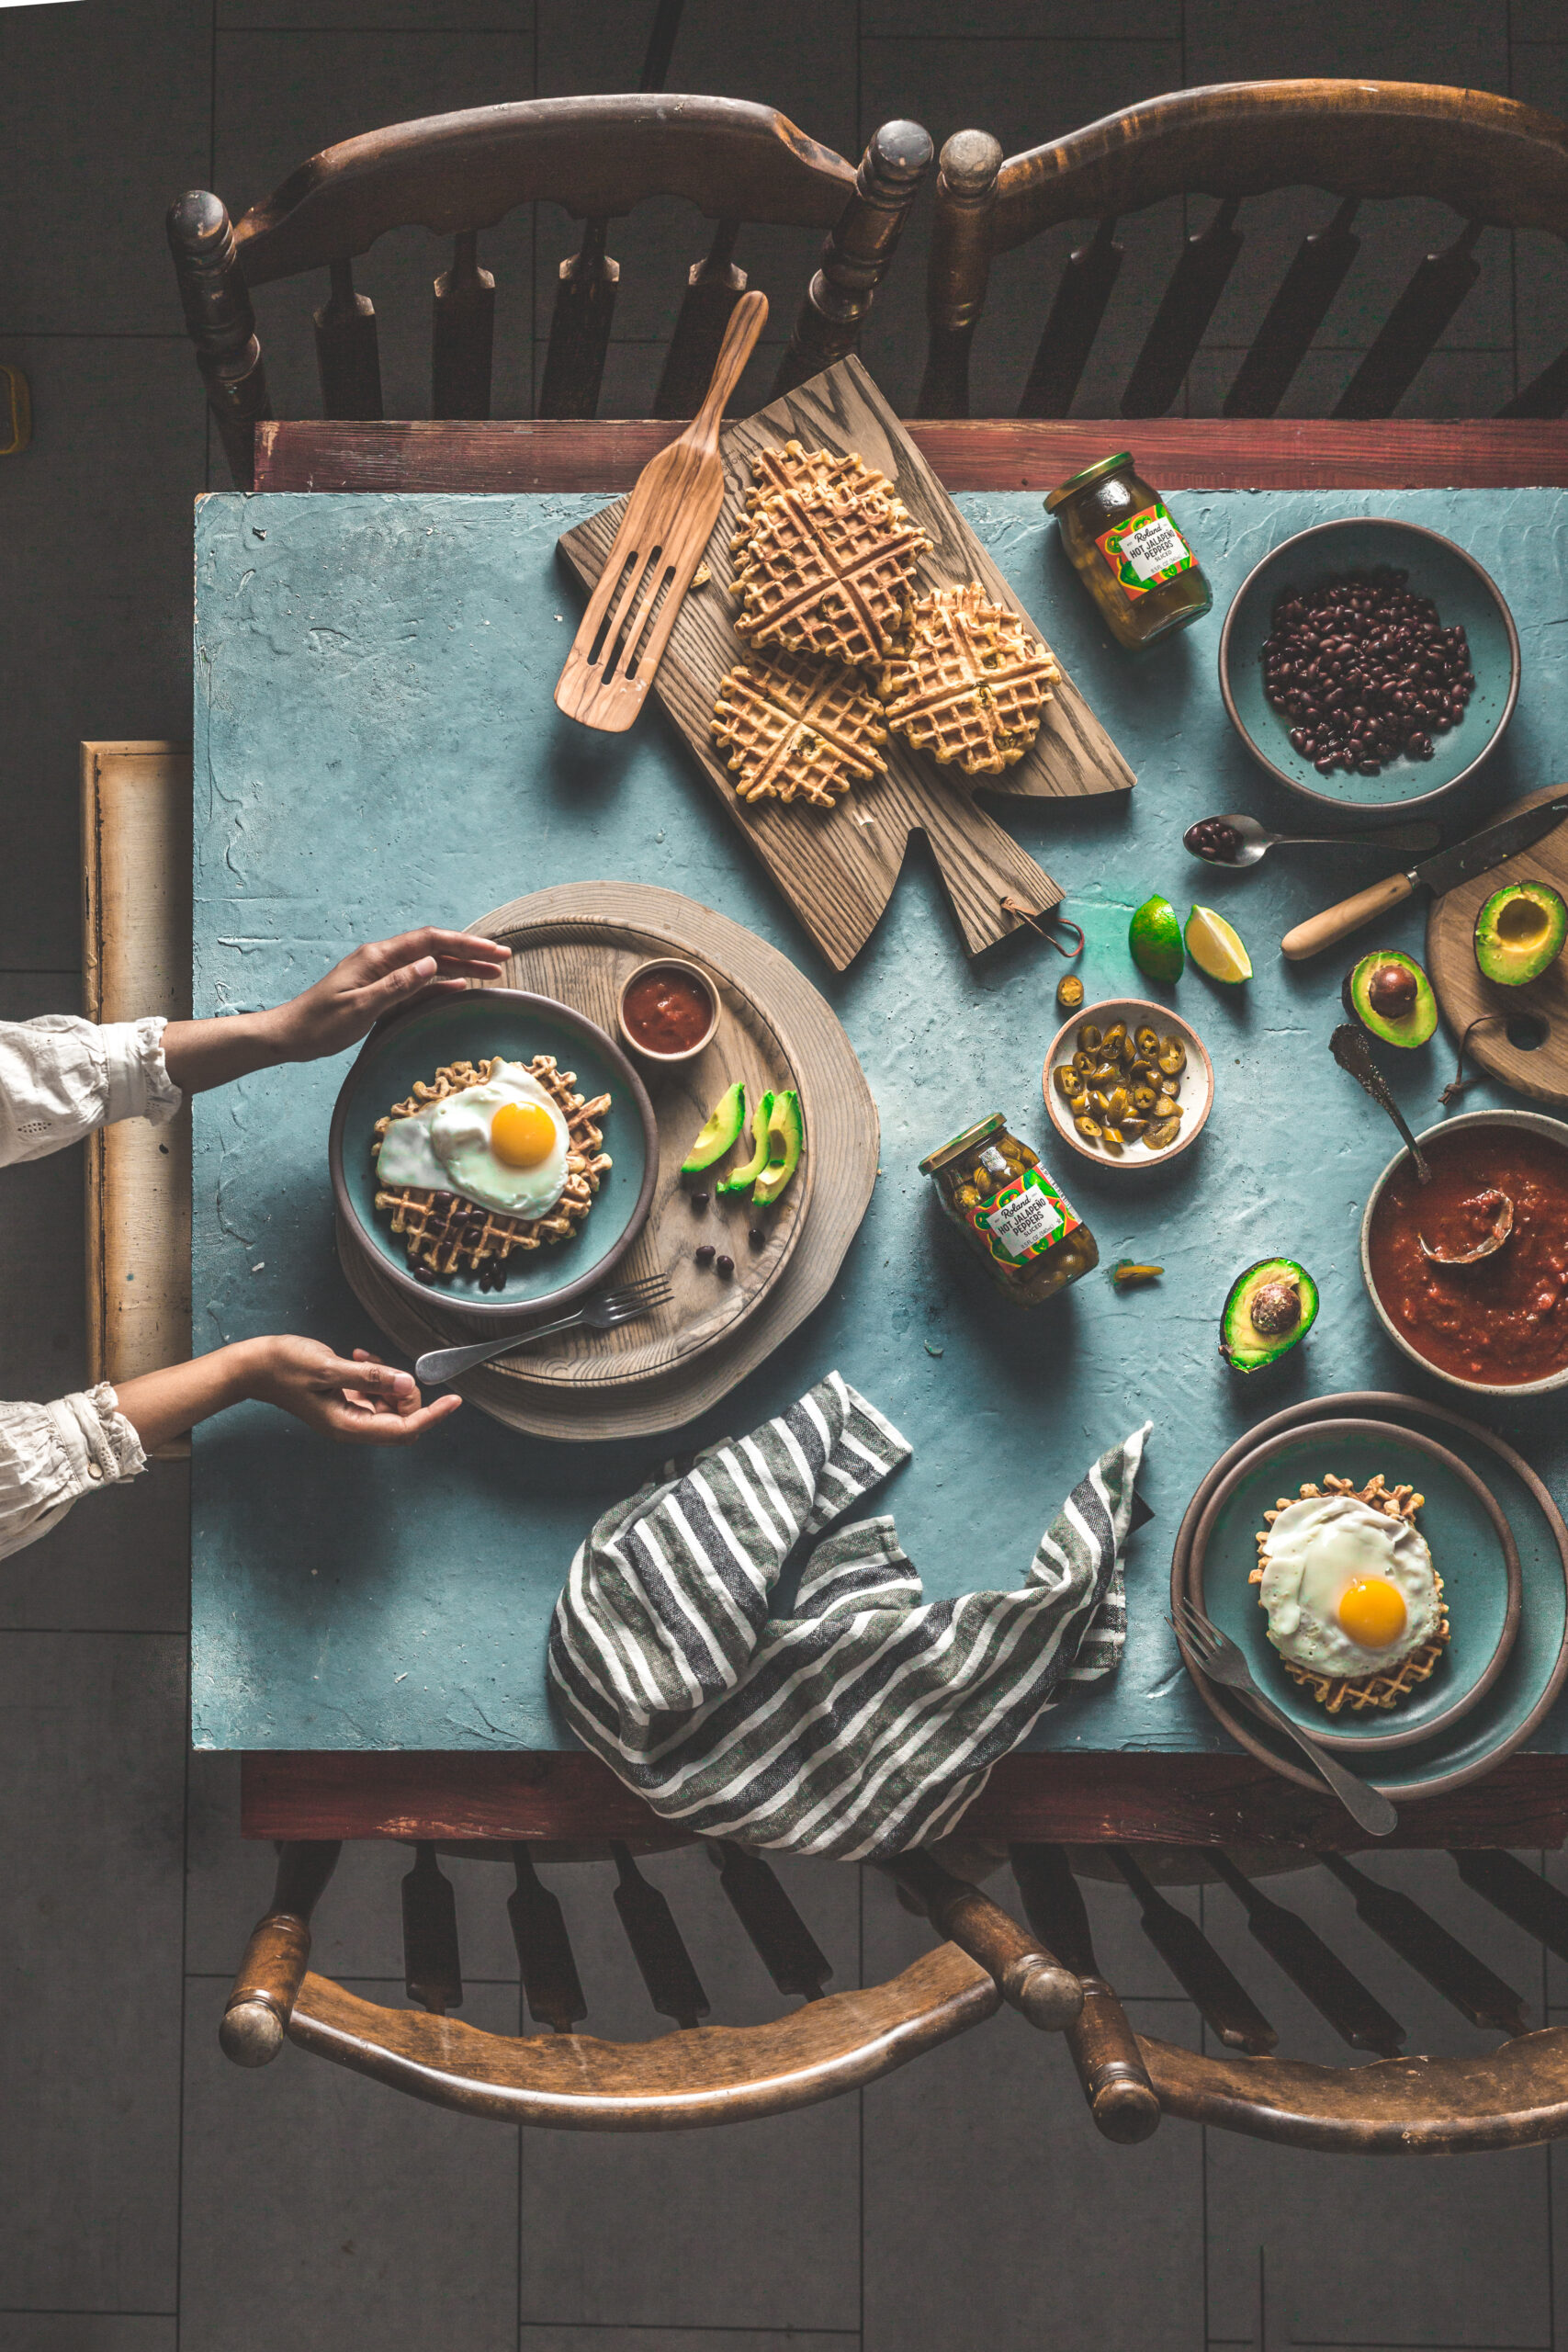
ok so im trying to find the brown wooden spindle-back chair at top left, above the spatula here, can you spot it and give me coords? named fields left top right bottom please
left=167, top=94, right=931, bottom=489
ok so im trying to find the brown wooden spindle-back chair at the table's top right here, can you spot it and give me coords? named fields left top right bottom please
left=919, top=83, right=1568, bottom=416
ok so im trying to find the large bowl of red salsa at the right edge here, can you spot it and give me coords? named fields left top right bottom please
left=1361, top=1110, right=1568, bottom=1397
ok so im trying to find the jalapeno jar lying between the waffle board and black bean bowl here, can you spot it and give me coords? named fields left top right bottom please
left=1046, top=449, right=1213, bottom=650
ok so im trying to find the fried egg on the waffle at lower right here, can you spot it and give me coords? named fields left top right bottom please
left=1258, top=1494, right=1441, bottom=1677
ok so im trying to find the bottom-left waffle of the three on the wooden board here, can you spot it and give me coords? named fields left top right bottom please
left=712, top=651, right=886, bottom=809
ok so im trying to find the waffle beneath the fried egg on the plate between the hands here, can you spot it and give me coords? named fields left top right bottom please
left=371, top=1054, right=611, bottom=1280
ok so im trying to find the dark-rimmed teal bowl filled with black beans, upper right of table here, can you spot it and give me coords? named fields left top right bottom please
left=1220, top=515, right=1518, bottom=814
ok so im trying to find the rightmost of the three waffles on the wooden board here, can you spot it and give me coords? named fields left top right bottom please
left=877, top=581, right=1063, bottom=776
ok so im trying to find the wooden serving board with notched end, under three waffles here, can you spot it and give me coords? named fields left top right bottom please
left=559, top=357, right=1134, bottom=971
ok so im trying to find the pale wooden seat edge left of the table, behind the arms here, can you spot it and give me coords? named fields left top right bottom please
left=83, top=743, right=190, bottom=1461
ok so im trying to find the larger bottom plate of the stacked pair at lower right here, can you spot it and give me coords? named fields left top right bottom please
left=1170, top=1390, right=1568, bottom=1804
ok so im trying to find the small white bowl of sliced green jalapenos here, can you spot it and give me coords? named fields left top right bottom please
left=1043, top=997, right=1213, bottom=1169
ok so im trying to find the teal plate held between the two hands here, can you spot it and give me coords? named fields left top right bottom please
left=327, top=988, right=659, bottom=1331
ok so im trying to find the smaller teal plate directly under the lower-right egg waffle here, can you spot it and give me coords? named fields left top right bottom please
left=1182, top=1420, right=1521, bottom=1752
